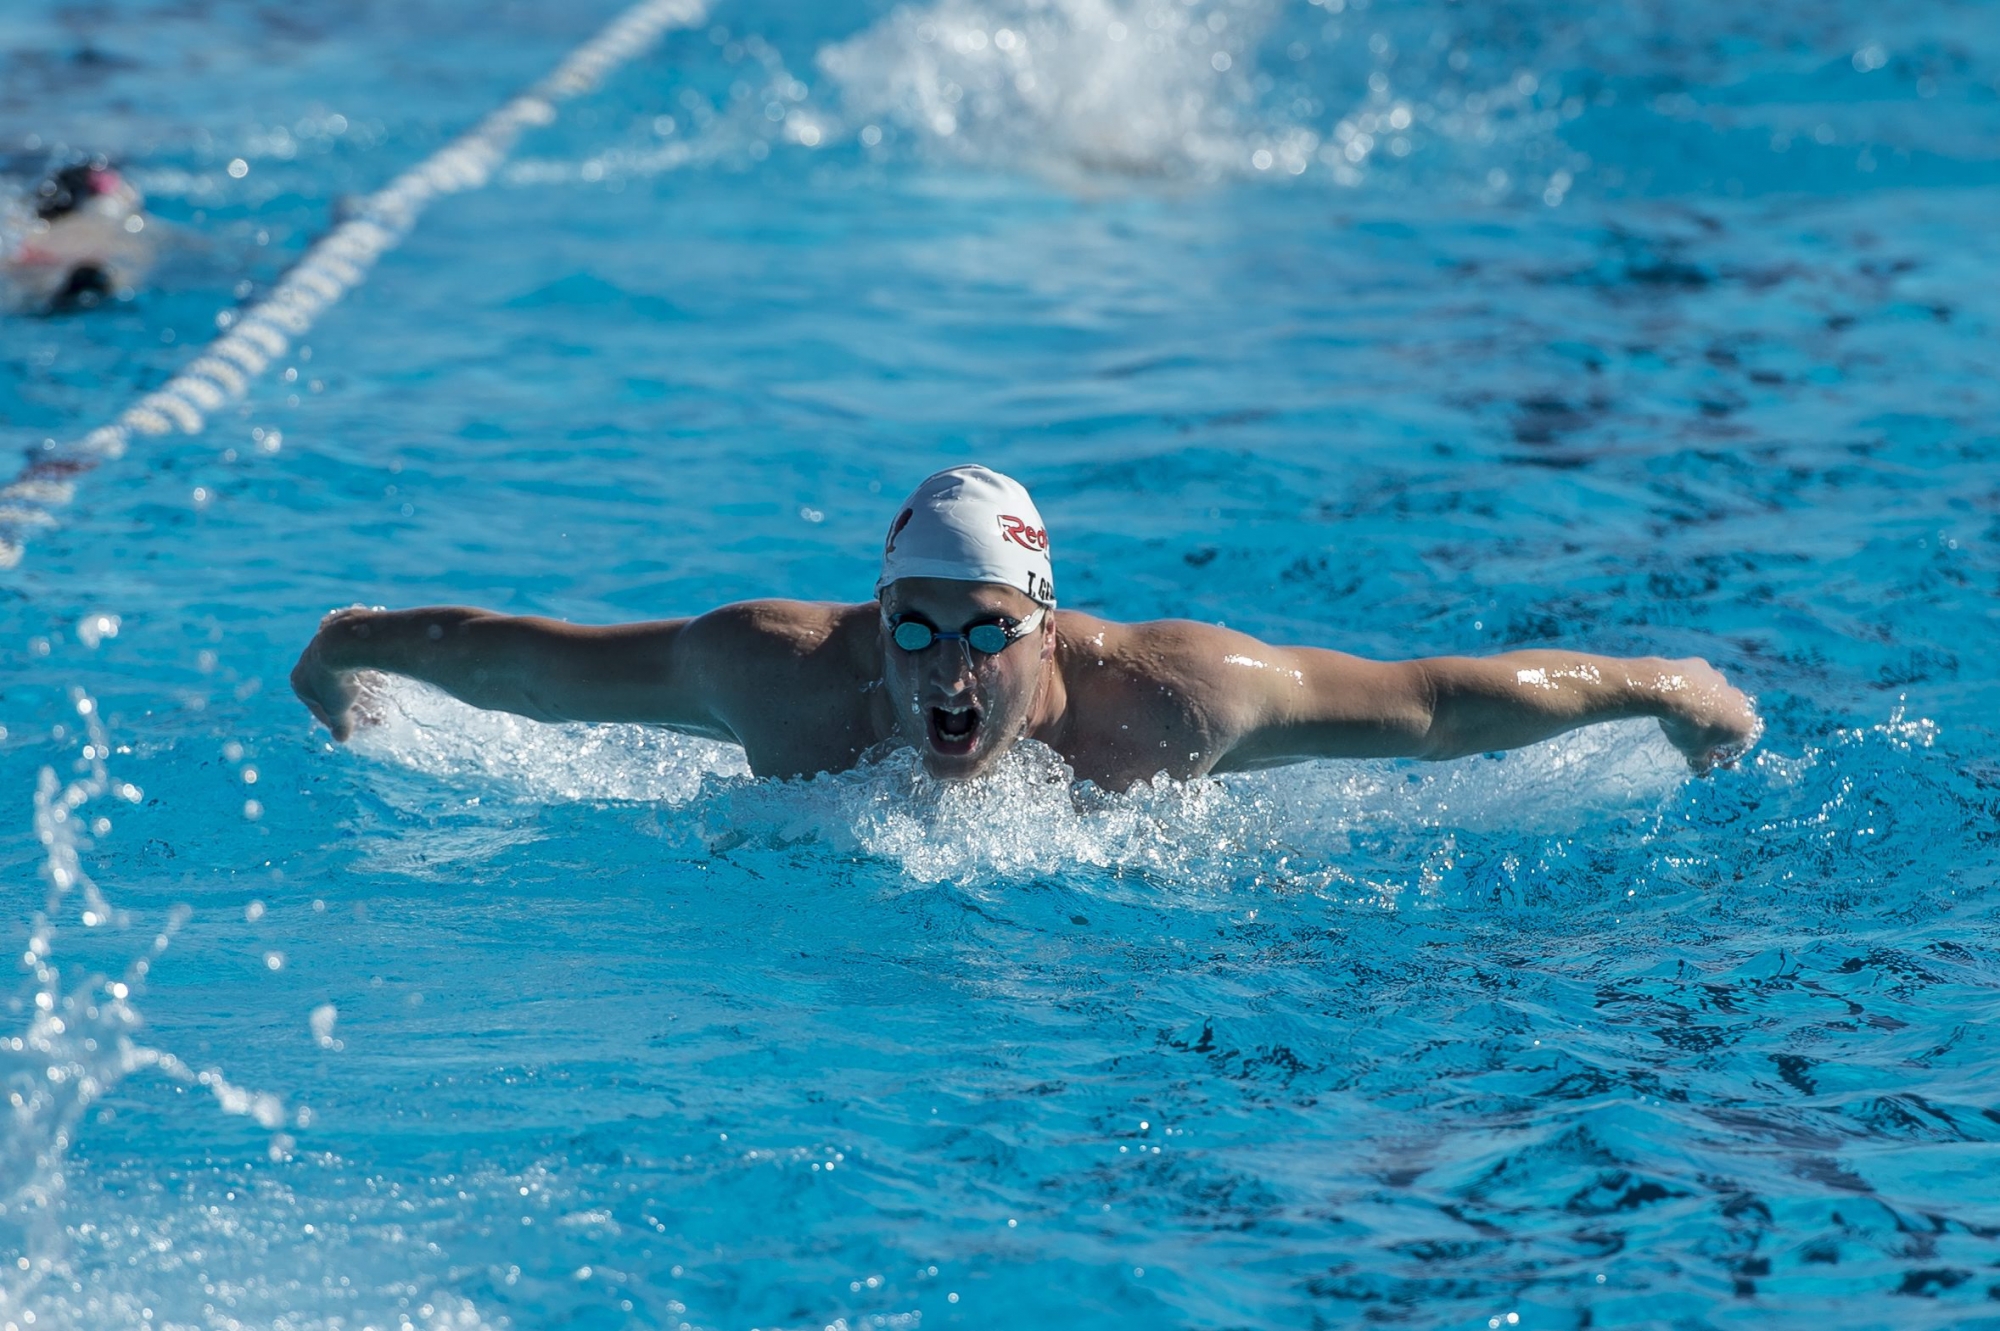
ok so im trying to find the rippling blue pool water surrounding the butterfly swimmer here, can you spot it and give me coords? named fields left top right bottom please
left=0, top=0, right=2000, bottom=1331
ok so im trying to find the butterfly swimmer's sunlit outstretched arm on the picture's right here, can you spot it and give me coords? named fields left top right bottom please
left=1218, top=648, right=1762, bottom=771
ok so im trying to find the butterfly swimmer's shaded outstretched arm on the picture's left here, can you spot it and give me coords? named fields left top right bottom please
left=292, top=606, right=752, bottom=741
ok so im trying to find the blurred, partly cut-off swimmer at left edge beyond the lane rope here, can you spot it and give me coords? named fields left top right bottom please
left=4, top=158, right=152, bottom=312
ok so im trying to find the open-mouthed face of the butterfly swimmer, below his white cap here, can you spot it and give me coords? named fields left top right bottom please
left=882, top=578, right=1054, bottom=777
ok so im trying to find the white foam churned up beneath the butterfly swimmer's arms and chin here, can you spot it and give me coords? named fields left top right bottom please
left=332, top=679, right=1978, bottom=927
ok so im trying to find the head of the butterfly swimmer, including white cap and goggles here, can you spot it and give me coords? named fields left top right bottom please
left=876, top=466, right=1056, bottom=777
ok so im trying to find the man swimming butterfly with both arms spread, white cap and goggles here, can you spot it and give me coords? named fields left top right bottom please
left=292, top=466, right=1760, bottom=789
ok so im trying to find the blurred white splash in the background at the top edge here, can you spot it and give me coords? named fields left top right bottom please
left=818, top=0, right=1590, bottom=190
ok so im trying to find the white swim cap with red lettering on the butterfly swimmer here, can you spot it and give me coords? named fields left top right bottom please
left=876, top=464, right=1056, bottom=606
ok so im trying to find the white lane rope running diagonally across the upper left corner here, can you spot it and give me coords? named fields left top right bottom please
left=0, top=0, right=708, bottom=570
